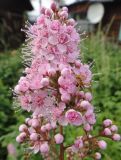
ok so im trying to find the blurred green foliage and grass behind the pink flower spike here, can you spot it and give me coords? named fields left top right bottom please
left=0, top=31, right=121, bottom=160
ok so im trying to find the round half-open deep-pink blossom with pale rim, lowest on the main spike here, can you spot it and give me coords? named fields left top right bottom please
left=65, top=109, right=83, bottom=126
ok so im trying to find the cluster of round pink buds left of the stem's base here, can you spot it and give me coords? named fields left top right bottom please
left=16, top=116, right=64, bottom=159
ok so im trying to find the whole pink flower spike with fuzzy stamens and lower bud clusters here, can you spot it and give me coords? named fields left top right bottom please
left=14, top=3, right=120, bottom=160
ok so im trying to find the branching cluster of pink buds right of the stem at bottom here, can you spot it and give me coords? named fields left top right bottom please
left=66, top=119, right=121, bottom=160
